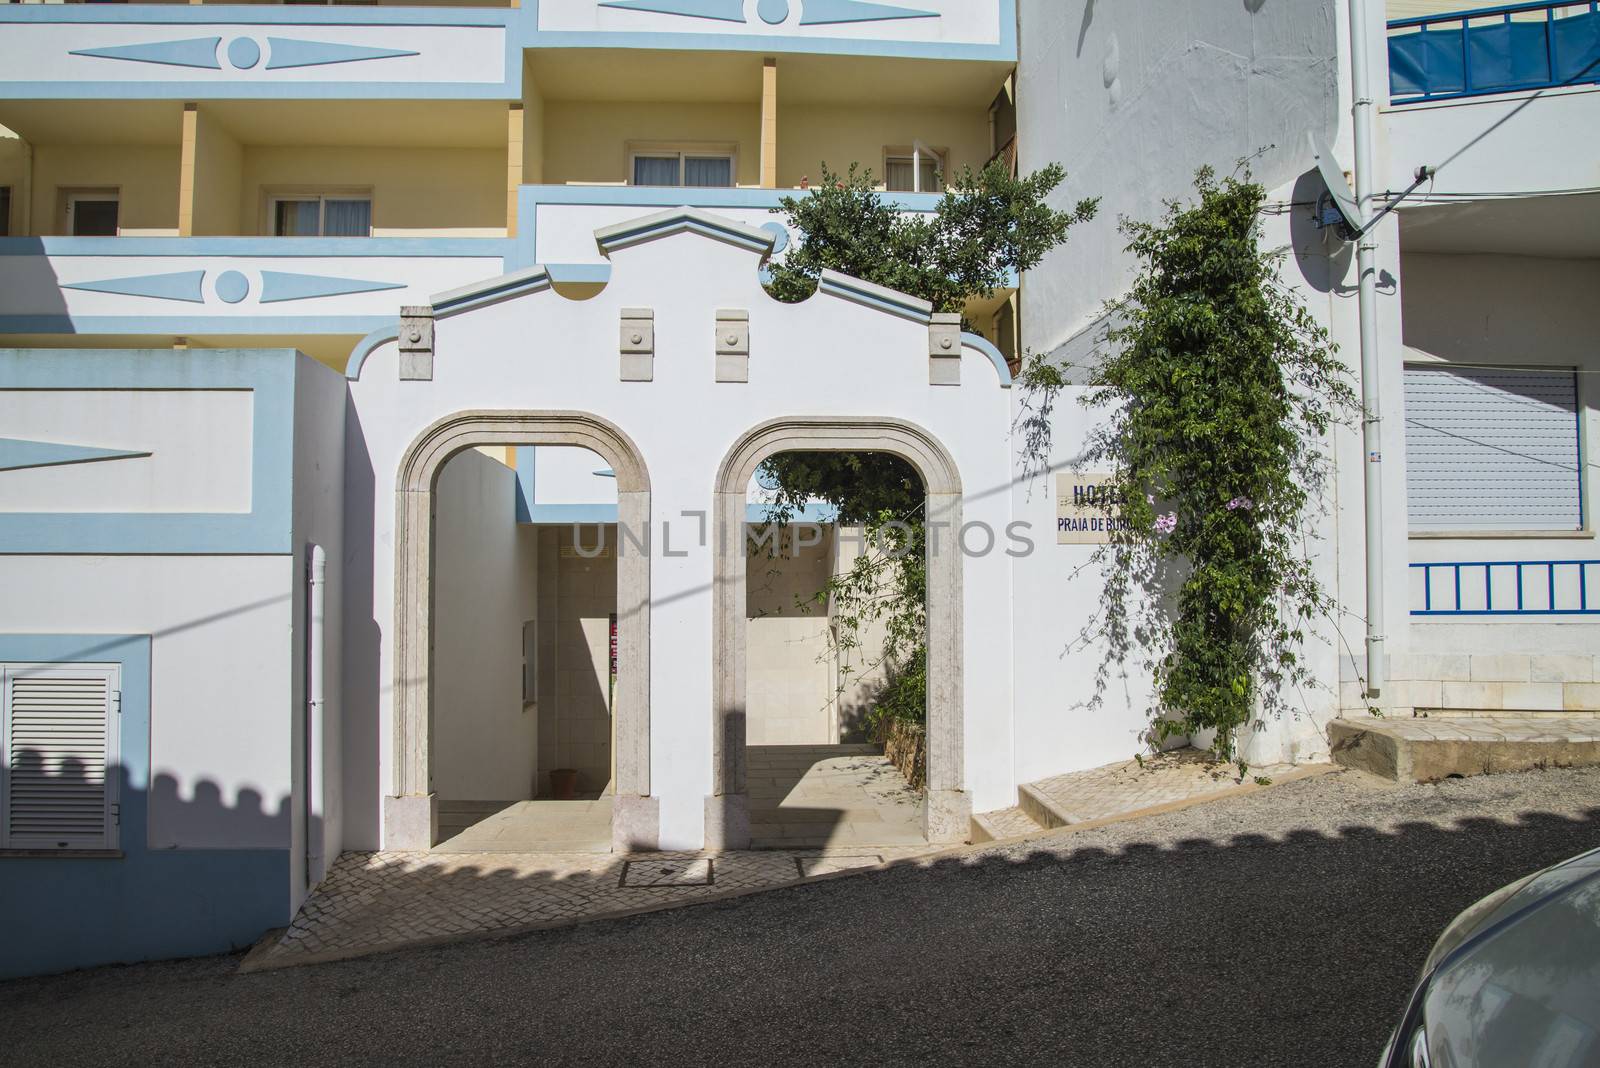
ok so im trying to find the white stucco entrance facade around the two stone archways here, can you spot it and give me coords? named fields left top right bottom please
left=349, top=220, right=1016, bottom=847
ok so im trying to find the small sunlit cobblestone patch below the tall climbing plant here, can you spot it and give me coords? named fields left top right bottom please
left=1030, top=750, right=1293, bottom=823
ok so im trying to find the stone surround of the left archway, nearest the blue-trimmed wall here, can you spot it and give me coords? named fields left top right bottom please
left=386, top=411, right=661, bottom=852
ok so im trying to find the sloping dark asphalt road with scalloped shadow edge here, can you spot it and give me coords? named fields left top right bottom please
left=0, top=769, right=1600, bottom=1068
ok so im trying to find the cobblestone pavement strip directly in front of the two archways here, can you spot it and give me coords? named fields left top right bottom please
left=243, top=844, right=934, bottom=970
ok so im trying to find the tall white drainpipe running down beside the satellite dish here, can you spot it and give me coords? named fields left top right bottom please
left=1350, top=0, right=1384, bottom=697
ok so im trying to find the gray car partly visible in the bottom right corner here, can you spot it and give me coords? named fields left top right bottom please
left=1378, top=849, right=1600, bottom=1068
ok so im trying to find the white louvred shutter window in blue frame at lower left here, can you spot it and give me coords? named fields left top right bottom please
left=0, top=664, right=122, bottom=849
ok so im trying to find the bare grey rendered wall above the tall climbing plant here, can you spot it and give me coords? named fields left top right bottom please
left=1018, top=0, right=1344, bottom=352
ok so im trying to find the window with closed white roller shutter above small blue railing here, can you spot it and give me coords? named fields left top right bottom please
left=1405, top=366, right=1582, bottom=531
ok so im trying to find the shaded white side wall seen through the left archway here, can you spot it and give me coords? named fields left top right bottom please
left=432, top=449, right=539, bottom=801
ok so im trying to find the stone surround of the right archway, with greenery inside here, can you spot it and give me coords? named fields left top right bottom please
left=706, top=417, right=971, bottom=849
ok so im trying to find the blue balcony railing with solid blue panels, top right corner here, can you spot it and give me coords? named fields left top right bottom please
left=1389, top=0, right=1600, bottom=104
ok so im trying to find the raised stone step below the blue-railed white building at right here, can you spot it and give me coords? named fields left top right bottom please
left=1328, top=713, right=1600, bottom=782
